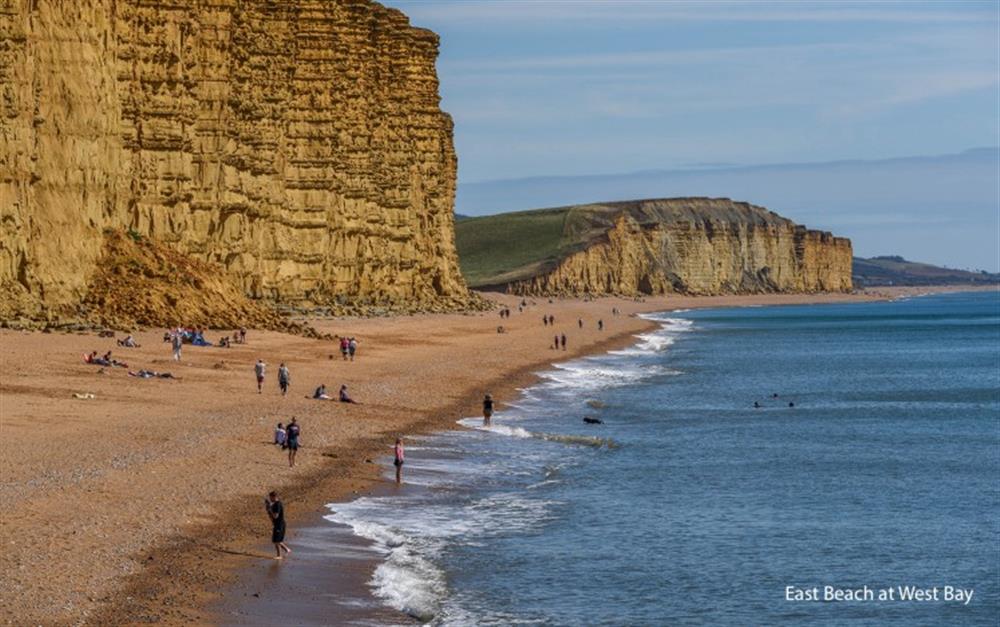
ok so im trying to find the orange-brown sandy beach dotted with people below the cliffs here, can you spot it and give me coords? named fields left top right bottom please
left=0, top=288, right=984, bottom=625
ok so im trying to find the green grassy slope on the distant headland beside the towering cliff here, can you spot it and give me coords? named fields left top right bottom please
left=455, top=205, right=610, bottom=287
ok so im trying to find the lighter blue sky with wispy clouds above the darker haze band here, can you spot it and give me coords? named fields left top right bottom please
left=385, top=0, right=1000, bottom=269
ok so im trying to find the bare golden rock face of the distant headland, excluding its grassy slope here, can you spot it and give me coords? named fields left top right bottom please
left=464, top=198, right=851, bottom=296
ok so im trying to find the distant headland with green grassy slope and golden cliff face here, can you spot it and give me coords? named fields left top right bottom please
left=457, top=198, right=851, bottom=296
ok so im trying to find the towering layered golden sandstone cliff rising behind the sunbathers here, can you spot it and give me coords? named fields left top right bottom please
left=0, top=0, right=468, bottom=324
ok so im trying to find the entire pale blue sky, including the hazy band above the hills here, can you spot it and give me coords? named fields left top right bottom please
left=385, top=0, right=1000, bottom=271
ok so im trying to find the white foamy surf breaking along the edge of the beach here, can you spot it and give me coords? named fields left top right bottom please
left=326, top=314, right=693, bottom=624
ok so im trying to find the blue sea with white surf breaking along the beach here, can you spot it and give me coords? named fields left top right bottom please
left=329, top=292, right=1000, bottom=625
